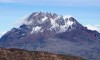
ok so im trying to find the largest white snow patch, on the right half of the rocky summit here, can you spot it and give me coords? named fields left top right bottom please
left=50, top=16, right=74, bottom=33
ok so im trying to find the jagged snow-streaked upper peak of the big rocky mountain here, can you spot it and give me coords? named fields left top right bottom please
left=20, top=12, right=79, bottom=33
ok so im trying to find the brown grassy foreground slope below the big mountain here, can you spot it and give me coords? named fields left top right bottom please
left=0, top=48, right=85, bottom=60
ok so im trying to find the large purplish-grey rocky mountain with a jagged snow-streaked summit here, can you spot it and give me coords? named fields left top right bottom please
left=0, top=12, right=100, bottom=60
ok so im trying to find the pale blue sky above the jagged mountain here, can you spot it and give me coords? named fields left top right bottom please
left=0, top=0, right=100, bottom=32
